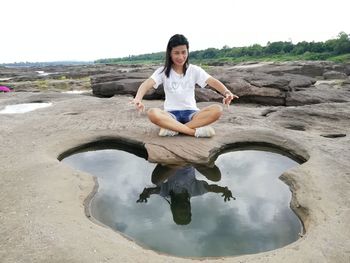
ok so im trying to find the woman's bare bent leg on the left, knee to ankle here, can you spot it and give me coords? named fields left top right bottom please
left=147, top=108, right=195, bottom=136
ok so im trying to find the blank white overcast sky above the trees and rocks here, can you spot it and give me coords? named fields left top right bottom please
left=0, top=0, right=350, bottom=63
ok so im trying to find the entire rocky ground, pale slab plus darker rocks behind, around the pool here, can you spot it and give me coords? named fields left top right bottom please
left=0, top=62, right=350, bottom=262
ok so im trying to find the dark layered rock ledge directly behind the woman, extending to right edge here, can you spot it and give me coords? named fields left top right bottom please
left=87, top=62, right=350, bottom=106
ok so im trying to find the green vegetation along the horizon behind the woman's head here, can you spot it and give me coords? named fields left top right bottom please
left=95, top=32, right=350, bottom=64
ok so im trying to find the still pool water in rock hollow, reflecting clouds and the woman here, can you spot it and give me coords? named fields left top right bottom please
left=62, top=150, right=302, bottom=257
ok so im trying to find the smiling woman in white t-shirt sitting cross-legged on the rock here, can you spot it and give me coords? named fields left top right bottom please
left=132, top=34, right=238, bottom=137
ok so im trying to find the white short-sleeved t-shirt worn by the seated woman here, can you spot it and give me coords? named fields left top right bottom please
left=151, top=64, right=210, bottom=111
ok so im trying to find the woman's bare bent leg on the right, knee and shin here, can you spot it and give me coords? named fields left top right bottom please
left=185, top=105, right=222, bottom=129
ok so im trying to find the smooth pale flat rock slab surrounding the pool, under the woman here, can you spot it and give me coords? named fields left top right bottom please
left=0, top=92, right=350, bottom=263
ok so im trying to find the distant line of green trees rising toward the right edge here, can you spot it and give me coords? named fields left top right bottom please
left=95, top=32, right=350, bottom=63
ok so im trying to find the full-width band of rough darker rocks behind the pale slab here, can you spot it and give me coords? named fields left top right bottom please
left=0, top=61, right=350, bottom=106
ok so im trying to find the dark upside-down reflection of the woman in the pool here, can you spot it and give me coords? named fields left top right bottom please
left=137, top=164, right=236, bottom=225
